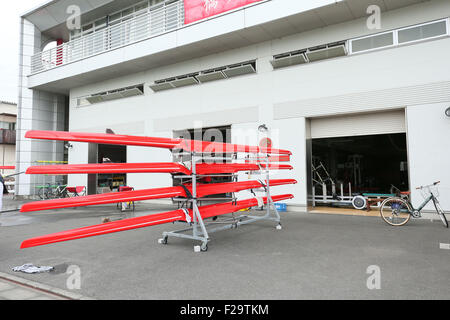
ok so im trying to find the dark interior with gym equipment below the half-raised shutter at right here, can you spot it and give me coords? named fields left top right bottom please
left=311, top=133, right=409, bottom=215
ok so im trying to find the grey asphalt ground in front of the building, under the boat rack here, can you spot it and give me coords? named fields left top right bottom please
left=0, top=204, right=450, bottom=300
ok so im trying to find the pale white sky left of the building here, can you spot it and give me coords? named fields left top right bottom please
left=0, top=0, right=47, bottom=102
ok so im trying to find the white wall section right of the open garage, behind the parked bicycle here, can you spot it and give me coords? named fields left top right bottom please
left=406, top=101, right=450, bottom=211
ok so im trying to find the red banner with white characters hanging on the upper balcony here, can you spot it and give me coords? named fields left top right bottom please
left=184, top=0, right=261, bottom=24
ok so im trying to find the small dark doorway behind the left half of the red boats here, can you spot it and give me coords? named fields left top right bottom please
left=97, top=144, right=127, bottom=193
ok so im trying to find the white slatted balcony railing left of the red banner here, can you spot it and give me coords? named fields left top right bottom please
left=31, top=1, right=184, bottom=74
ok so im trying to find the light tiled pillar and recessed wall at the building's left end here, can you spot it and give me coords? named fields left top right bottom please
left=15, top=19, right=66, bottom=196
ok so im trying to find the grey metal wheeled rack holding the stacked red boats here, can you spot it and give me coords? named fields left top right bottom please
left=158, top=152, right=282, bottom=252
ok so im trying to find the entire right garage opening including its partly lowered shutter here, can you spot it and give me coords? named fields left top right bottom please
left=309, top=110, right=409, bottom=212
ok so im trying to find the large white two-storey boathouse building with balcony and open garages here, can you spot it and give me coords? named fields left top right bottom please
left=16, top=0, right=450, bottom=210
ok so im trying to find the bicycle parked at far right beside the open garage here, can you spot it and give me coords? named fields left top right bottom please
left=380, top=181, right=448, bottom=228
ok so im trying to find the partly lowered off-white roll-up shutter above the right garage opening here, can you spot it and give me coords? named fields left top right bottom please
left=311, top=109, right=406, bottom=139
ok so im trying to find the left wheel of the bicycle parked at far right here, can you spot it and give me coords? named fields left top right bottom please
left=380, top=198, right=412, bottom=227
